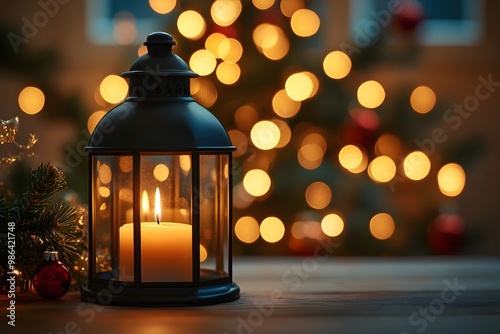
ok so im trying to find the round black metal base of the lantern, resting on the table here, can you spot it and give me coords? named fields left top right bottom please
left=80, top=282, right=240, bottom=306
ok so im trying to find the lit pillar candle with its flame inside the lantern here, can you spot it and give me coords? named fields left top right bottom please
left=119, top=188, right=193, bottom=282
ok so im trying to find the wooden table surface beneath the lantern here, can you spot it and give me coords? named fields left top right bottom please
left=0, top=257, right=500, bottom=334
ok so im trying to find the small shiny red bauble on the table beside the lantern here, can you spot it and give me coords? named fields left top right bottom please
left=33, top=247, right=71, bottom=300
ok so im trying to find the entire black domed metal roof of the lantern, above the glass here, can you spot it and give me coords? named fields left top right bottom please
left=86, top=32, right=236, bottom=152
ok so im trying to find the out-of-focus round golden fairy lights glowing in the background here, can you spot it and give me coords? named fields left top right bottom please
left=14, top=0, right=466, bottom=250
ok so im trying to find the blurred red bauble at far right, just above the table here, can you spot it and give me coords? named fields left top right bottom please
left=427, top=214, right=465, bottom=255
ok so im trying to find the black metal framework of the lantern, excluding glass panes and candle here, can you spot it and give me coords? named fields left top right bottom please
left=81, top=32, right=240, bottom=306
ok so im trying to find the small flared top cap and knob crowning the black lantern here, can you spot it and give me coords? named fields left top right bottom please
left=122, top=32, right=198, bottom=77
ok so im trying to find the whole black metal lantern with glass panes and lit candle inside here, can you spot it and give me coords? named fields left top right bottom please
left=81, top=32, right=240, bottom=305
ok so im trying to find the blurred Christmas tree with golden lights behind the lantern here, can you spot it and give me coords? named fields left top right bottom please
left=135, top=0, right=478, bottom=255
